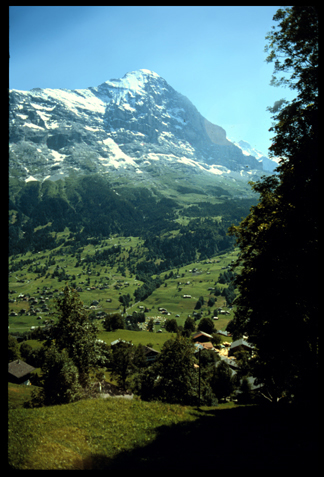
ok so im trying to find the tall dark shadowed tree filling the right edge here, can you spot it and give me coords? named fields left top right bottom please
left=230, top=6, right=318, bottom=401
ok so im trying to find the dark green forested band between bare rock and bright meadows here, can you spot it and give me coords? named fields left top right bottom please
left=9, top=174, right=256, bottom=260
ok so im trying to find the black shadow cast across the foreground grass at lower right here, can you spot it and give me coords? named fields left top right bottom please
left=79, top=406, right=318, bottom=471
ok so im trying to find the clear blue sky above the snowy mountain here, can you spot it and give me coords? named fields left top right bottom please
left=9, top=6, right=293, bottom=154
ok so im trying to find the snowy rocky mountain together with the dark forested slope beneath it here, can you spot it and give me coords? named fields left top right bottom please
left=9, top=70, right=265, bottom=256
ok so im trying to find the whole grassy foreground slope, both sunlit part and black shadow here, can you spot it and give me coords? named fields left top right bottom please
left=8, top=386, right=318, bottom=470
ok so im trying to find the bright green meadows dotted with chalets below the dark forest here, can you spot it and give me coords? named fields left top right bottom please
left=8, top=235, right=238, bottom=332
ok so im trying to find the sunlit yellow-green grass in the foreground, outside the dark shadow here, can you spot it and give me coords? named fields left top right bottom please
left=8, top=398, right=200, bottom=470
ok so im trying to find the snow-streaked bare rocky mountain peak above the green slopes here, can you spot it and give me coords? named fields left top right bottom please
left=9, top=69, right=270, bottom=187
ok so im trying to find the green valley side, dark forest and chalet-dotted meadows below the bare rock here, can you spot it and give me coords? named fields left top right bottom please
left=8, top=174, right=253, bottom=333
